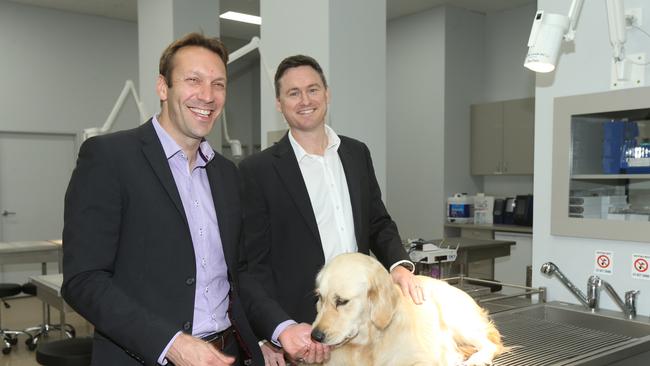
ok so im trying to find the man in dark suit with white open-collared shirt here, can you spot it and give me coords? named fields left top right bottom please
left=239, top=55, right=422, bottom=365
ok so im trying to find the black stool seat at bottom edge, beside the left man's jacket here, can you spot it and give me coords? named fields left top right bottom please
left=36, top=337, right=93, bottom=366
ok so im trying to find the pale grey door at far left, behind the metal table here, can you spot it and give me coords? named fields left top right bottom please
left=0, top=132, right=77, bottom=283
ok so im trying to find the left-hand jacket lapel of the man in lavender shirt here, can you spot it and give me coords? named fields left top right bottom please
left=140, top=120, right=189, bottom=227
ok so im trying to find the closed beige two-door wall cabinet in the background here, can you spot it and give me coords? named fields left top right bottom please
left=471, top=98, right=535, bottom=175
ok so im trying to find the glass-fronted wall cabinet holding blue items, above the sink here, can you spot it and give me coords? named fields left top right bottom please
left=551, top=84, right=650, bottom=242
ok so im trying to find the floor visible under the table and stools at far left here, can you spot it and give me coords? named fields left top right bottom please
left=0, top=296, right=92, bottom=366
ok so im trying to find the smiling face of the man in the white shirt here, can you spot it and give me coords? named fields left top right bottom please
left=275, top=66, right=329, bottom=131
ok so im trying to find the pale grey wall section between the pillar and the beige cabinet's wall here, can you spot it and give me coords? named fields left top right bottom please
left=386, top=7, right=445, bottom=238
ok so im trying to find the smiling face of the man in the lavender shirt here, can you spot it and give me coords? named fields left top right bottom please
left=157, top=46, right=226, bottom=147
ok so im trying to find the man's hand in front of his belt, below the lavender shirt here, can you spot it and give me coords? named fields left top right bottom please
left=166, top=334, right=235, bottom=366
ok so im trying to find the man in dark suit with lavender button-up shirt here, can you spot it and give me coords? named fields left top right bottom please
left=62, top=33, right=264, bottom=366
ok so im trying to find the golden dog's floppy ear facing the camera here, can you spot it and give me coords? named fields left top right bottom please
left=368, top=268, right=400, bottom=329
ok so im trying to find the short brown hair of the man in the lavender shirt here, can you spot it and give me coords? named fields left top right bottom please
left=158, top=32, right=228, bottom=88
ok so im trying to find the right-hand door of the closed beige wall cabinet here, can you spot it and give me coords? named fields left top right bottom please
left=502, top=98, right=535, bottom=175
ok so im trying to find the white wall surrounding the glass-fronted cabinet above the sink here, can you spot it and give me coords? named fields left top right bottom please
left=533, top=0, right=650, bottom=315
